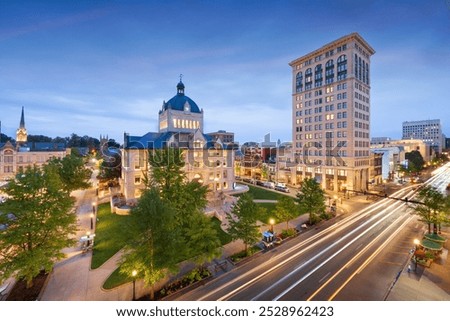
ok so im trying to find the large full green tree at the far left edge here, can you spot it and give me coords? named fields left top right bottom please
left=0, top=166, right=76, bottom=287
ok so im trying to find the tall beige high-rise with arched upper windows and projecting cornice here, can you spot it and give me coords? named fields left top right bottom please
left=289, top=33, right=375, bottom=192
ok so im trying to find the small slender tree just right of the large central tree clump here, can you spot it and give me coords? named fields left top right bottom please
left=227, top=193, right=260, bottom=252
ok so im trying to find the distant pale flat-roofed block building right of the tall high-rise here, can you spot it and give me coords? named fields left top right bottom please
left=402, top=119, right=443, bottom=153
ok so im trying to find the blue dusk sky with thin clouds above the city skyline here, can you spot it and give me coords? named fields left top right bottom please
left=0, top=0, right=450, bottom=143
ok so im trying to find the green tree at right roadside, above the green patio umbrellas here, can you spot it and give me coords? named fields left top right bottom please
left=410, top=186, right=448, bottom=234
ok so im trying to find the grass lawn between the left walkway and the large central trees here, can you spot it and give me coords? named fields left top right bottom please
left=91, top=203, right=130, bottom=269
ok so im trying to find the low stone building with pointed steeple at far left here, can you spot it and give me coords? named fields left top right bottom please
left=0, top=107, right=70, bottom=180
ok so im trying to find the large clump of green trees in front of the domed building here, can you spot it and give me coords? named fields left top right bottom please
left=121, top=148, right=221, bottom=298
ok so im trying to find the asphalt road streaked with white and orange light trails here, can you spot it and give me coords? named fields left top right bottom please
left=178, top=162, right=450, bottom=301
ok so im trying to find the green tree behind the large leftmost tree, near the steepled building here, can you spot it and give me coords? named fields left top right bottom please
left=46, top=155, right=92, bottom=193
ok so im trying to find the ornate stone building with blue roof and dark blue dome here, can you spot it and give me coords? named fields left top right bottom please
left=120, top=80, right=235, bottom=202
